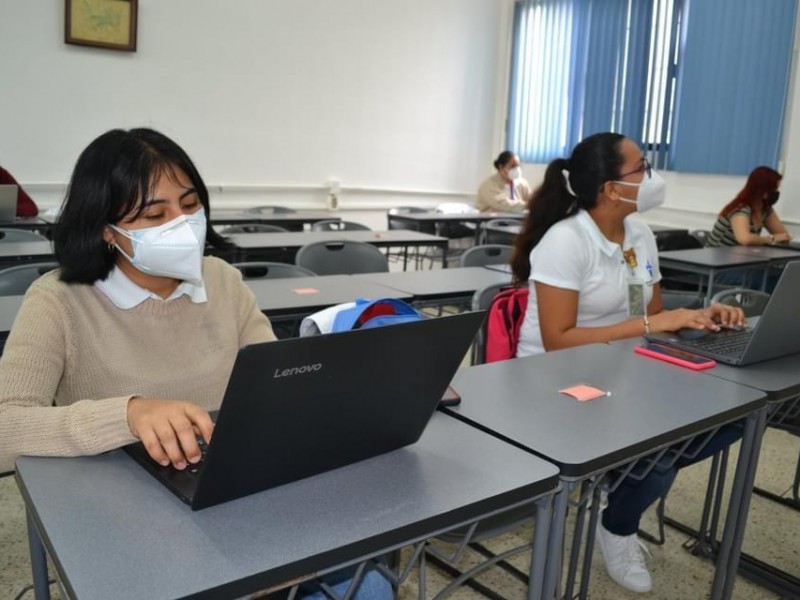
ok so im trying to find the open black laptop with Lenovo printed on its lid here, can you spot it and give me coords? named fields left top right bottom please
left=126, top=311, right=484, bottom=510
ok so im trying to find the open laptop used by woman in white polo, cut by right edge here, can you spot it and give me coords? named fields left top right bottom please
left=645, top=261, right=800, bottom=366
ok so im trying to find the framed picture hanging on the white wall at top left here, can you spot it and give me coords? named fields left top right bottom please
left=64, top=0, right=138, bottom=52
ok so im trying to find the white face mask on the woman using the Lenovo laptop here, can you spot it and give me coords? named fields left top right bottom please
left=109, top=209, right=206, bottom=284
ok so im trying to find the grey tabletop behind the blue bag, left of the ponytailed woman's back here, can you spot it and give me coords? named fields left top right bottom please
left=358, top=267, right=511, bottom=298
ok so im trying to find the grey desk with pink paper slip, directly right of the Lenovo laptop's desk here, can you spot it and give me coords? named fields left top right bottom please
left=443, top=344, right=765, bottom=599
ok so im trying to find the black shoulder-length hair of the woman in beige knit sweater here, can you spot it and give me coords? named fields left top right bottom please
left=53, top=128, right=231, bottom=284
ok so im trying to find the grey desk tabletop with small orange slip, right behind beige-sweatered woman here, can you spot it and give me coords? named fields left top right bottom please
left=245, top=274, right=411, bottom=313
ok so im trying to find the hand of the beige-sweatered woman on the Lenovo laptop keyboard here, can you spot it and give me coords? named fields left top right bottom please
left=128, top=396, right=214, bottom=469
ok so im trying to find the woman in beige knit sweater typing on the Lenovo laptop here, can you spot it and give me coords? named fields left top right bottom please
left=0, top=129, right=391, bottom=598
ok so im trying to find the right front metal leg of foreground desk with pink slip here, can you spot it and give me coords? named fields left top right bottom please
left=711, top=408, right=767, bottom=600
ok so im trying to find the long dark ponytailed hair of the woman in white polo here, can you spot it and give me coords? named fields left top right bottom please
left=511, top=133, right=625, bottom=283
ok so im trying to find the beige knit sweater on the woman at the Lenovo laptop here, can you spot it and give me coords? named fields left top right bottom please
left=0, top=258, right=275, bottom=472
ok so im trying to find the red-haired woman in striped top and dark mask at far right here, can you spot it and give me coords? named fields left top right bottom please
left=706, top=167, right=791, bottom=248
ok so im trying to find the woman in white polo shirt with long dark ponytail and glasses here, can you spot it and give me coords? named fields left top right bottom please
left=511, top=133, right=744, bottom=592
